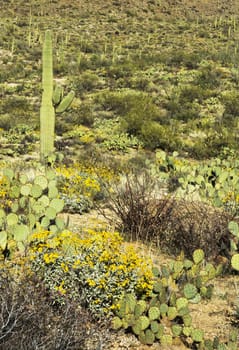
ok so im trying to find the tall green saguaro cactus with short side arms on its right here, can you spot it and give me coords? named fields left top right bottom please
left=40, top=30, right=75, bottom=163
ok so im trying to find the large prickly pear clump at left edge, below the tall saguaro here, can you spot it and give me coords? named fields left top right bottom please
left=0, top=169, right=65, bottom=254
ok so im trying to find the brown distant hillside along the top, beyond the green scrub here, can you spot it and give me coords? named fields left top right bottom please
left=0, top=0, right=239, bottom=18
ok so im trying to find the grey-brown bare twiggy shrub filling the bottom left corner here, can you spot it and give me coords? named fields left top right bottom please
left=0, top=263, right=99, bottom=350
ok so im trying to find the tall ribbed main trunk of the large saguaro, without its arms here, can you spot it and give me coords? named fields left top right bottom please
left=40, top=30, right=55, bottom=163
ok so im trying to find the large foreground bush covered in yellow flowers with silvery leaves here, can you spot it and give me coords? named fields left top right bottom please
left=30, top=230, right=153, bottom=317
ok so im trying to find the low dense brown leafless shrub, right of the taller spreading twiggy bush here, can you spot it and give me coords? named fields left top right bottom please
left=158, top=200, right=231, bottom=259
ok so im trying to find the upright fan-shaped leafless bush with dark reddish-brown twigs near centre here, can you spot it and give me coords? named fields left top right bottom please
left=103, top=172, right=171, bottom=242
